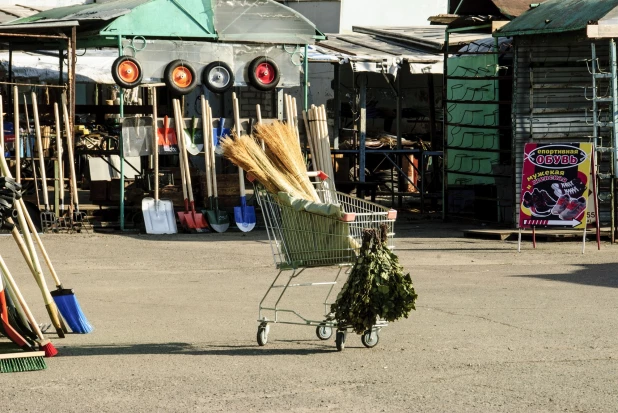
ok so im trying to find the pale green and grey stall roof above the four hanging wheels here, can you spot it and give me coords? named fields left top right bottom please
left=0, top=0, right=324, bottom=46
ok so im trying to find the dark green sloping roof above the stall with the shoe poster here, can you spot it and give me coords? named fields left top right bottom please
left=494, top=0, right=618, bottom=37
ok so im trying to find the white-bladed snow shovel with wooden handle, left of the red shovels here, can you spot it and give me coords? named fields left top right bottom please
left=142, top=89, right=178, bottom=234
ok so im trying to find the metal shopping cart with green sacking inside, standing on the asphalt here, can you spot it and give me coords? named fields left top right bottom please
left=255, top=172, right=397, bottom=351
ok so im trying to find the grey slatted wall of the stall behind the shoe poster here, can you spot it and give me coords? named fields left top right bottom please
left=513, top=34, right=611, bottom=225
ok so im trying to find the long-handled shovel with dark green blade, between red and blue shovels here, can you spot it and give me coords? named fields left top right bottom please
left=202, top=95, right=230, bottom=232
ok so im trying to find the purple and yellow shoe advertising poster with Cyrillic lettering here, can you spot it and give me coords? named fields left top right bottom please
left=519, top=143, right=592, bottom=229
